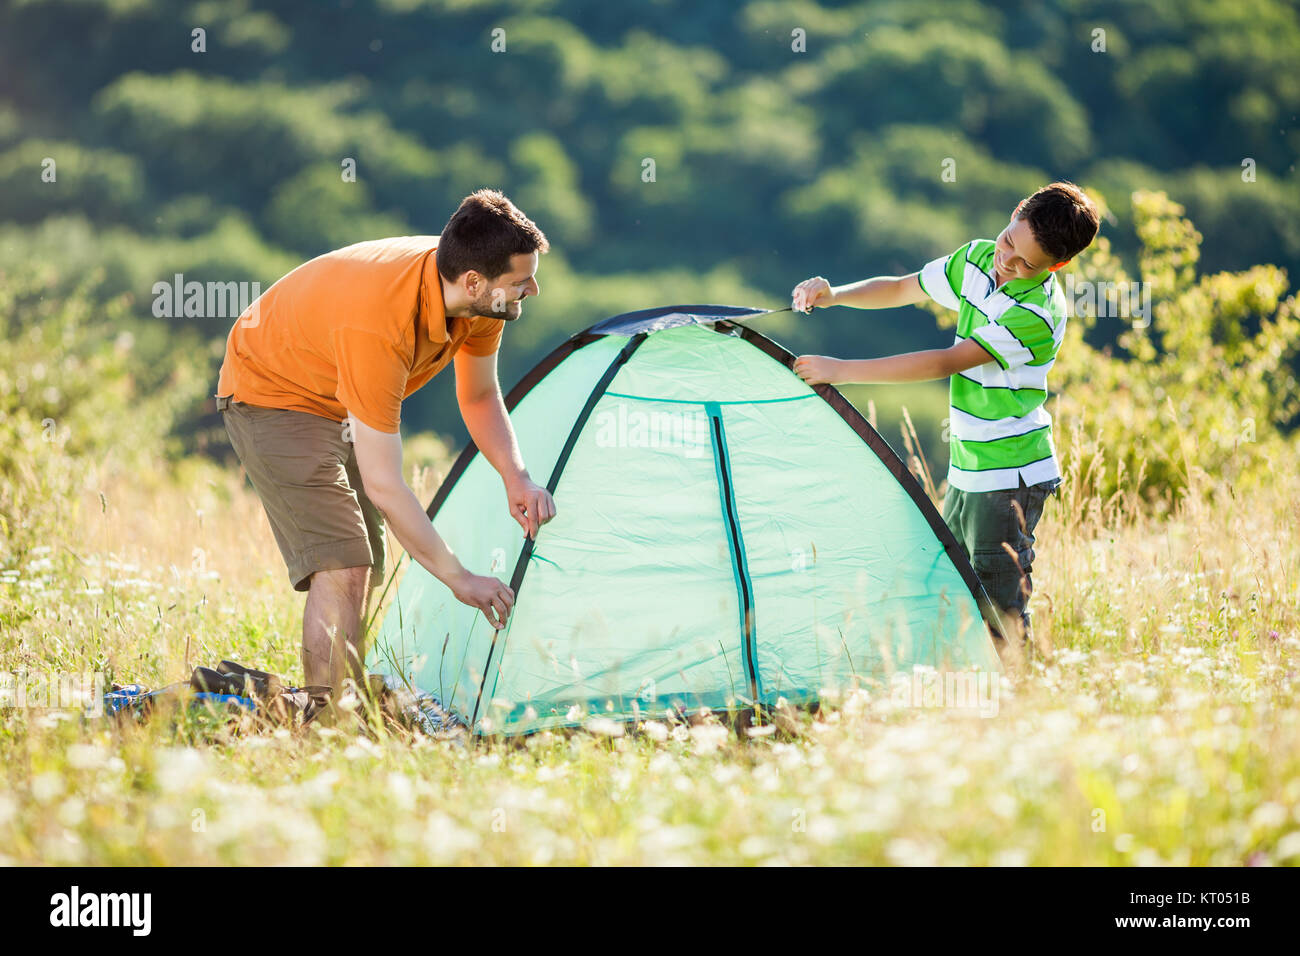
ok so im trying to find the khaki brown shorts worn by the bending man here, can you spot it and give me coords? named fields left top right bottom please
left=217, top=397, right=385, bottom=591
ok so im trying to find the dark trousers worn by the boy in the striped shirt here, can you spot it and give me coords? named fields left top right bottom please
left=944, top=479, right=1061, bottom=622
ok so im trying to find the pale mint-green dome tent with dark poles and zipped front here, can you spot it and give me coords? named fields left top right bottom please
left=368, top=306, right=998, bottom=734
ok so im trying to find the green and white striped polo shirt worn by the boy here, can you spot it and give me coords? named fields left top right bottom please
left=920, top=239, right=1066, bottom=492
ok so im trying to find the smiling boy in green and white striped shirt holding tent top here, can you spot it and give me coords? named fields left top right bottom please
left=793, top=182, right=1099, bottom=643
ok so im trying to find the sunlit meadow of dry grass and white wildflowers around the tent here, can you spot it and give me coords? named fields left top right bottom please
left=0, top=436, right=1300, bottom=865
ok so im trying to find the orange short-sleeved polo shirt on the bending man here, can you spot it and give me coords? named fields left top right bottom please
left=217, top=235, right=504, bottom=433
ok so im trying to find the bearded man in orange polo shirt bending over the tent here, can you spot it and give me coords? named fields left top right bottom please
left=217, top=190, right=555, bottom=702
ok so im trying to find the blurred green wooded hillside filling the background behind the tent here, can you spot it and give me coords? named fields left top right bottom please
left=0, top=0, right=1300, bottom=490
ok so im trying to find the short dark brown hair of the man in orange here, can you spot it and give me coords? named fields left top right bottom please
left=437, top=189, right=551, bottom=282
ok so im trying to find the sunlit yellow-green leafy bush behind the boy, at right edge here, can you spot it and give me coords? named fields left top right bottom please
left=1049, top=193, right=1300, bottom=505
